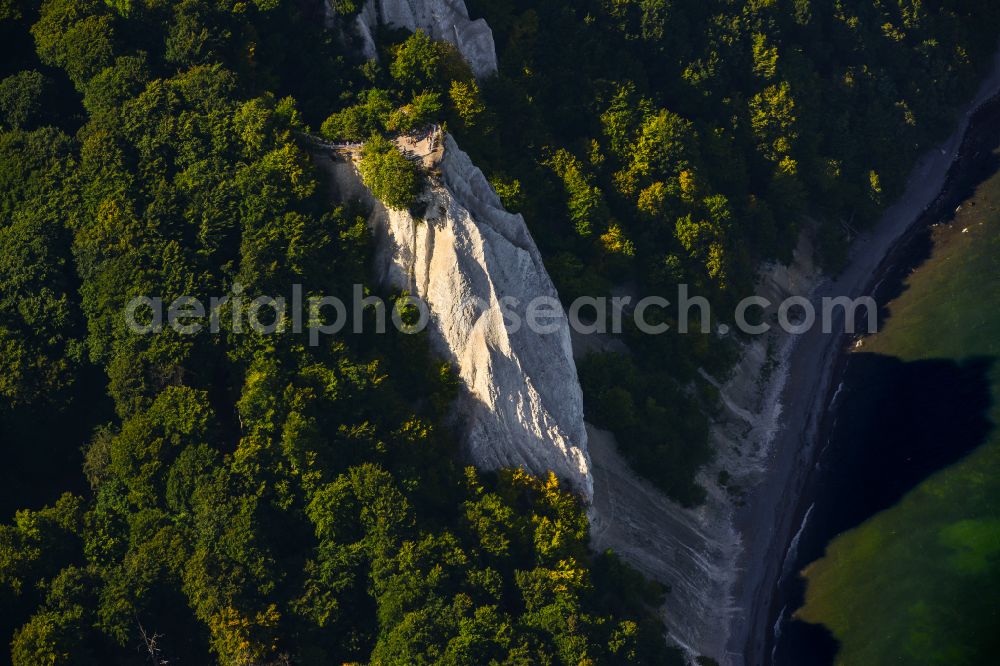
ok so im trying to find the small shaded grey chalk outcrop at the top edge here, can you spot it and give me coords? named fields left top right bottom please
left=326, top=0, right=497, bottom=79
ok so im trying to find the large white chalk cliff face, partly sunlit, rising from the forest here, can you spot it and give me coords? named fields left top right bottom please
left=316, top=132, right=593, bottom=502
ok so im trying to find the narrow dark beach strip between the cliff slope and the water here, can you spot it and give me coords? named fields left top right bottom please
left=725, top=52, right=1000, bottom=665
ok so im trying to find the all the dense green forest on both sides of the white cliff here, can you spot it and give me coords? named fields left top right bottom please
left=0, top=0, right=1000, bottom=666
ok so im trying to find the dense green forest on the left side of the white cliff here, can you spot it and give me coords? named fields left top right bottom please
left=0, top=0, right=674, bottom=666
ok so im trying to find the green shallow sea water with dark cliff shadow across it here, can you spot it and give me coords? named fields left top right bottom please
left=795, top=158, right=1000, bottom=665
